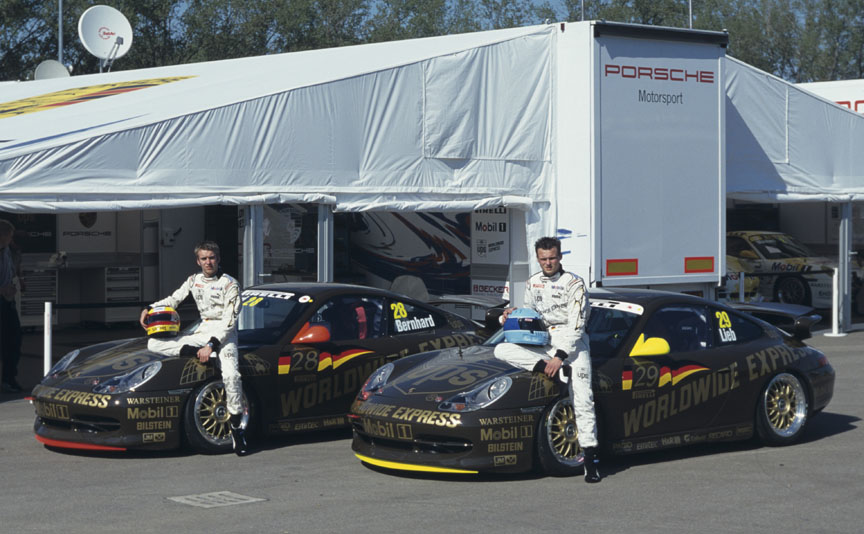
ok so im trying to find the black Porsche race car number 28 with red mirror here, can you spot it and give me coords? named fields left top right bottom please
left=32, top=284, right=482, bottom=452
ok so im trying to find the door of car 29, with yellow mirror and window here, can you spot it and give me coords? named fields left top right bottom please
left=607, top=302, right=734, bottom=441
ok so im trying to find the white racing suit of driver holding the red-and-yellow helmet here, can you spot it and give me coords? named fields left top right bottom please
left=147, top=273, right=243, bottom=415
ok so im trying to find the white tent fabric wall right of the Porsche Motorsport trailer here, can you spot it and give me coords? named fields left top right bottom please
left=725, top=57, right=864, bottom=202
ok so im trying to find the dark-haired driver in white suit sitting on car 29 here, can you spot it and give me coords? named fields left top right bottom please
left=495, top=237, right=600, bottom=482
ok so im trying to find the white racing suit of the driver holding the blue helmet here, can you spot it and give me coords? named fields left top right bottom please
left=495, top=271, right=597, bottom=449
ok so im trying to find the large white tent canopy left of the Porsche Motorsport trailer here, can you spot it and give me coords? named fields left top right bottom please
left=0, top=25, right=555, bottom=216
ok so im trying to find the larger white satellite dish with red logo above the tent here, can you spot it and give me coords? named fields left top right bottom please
left=78, top=6, right=132, bottom=72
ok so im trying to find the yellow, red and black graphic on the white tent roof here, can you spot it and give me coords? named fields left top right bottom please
left=0, top=76, right=195, bottom=119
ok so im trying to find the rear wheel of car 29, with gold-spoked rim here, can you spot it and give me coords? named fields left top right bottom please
left=756, top=373, right=808, bottom=445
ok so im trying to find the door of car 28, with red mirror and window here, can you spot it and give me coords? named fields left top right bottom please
left=278, top=294, right=393, bottom=431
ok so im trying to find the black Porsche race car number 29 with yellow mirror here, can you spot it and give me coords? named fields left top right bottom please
left=349, top=290, right=834, bottom=474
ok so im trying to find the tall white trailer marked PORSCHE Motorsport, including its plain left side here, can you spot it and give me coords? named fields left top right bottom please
left=510, top=22, right=728, bottom=304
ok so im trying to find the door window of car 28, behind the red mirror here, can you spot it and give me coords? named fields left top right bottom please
left=312, top=295, right=385, bottom=341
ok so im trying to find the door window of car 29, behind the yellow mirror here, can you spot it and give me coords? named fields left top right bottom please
left=643, top=305, right=714, bottom=354
